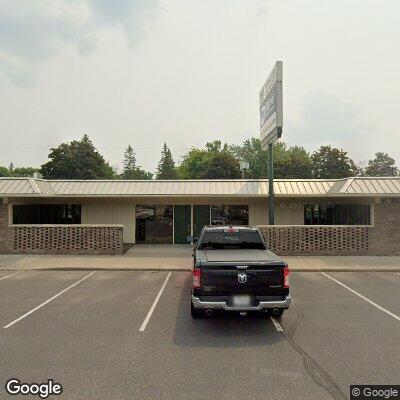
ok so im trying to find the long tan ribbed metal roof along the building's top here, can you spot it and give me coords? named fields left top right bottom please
left=0, top=177, right=400, bottom=199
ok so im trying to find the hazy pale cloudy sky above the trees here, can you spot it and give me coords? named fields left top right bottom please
left=0, top=0, right=400, bottom=170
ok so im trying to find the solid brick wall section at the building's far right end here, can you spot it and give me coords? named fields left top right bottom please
left=369, top=203, right=400, bottom=256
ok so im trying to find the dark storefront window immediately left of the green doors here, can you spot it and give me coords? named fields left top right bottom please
left=136, top=205, right=173, bottom=244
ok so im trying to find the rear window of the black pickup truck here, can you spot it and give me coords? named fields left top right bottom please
left=198, top=231, right=265, bottom=250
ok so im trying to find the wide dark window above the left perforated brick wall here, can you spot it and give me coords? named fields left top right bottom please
left=13, top=204, right=81, bottom=224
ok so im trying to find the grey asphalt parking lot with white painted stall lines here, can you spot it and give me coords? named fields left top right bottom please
left=0, top=271, right=400, bottom=400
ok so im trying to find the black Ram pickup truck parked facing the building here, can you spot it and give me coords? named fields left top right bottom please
left=191, top=226, right=291, bottom=318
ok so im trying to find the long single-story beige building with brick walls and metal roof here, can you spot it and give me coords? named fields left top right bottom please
left=0, top=177, right=400, bottom=255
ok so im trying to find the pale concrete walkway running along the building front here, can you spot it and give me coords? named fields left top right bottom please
left=0, top=245, right=400, bottom=272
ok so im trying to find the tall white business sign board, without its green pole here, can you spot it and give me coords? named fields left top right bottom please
left=260, top=61, right=283, bottom=150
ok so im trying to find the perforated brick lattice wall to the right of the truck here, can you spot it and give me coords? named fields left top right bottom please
left=259, top=225, right=372, bottom=255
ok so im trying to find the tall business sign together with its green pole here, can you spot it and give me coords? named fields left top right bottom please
left=260, top=61, right=283, bottom=225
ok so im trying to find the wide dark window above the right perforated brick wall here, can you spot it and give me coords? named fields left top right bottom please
left=304, top=204, right=371, bottom=225
